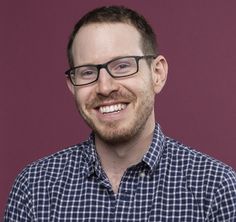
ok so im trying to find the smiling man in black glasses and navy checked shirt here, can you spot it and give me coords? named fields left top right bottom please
left=5, top=7, right=236, bottom=222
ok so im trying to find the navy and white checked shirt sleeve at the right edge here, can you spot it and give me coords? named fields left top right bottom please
left=208, top=170, right=236, bottom=222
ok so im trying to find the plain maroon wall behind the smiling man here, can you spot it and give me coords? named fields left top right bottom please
left=0, top=0, right=236, bottom=217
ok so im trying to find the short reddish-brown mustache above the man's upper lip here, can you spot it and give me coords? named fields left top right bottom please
left=87, top=92, right=136, bottom=108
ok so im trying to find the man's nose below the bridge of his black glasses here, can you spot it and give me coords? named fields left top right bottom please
left=97, top=68, right=118, bottom=96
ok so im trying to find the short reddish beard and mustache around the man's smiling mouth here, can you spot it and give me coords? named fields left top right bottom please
left=76, top=87, right=154, bottom=144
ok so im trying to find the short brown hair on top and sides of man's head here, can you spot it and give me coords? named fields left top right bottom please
left=67, top=6, right=158, bottom=67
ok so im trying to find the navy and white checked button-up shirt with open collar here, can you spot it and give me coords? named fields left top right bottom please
left=5, top=124, right=236, bottom=222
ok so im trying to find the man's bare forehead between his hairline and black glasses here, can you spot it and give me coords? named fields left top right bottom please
left=72, top=23, right=142, bottom=63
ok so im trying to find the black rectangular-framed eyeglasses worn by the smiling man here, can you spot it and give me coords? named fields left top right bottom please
left=65, top=55, right=156, bottom=86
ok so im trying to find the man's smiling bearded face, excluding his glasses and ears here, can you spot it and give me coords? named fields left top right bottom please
left=68, top=23, right=166, bottom=143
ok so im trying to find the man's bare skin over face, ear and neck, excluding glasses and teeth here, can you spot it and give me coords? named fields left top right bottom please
left=67, top=23, right=167, bottom=191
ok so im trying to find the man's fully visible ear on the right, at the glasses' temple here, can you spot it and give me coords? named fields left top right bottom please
left=151, top=55, right=168, bottom=94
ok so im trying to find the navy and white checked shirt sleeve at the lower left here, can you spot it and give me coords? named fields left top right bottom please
left=4, top=169, right=34, bottom=222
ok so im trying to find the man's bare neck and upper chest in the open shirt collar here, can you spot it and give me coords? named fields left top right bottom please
left=95, top=119, right=155, bottom=192
